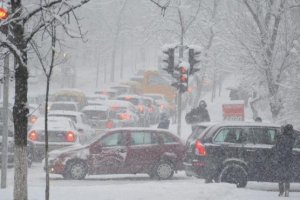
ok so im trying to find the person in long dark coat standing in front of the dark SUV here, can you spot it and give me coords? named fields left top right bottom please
left=273, top=124, right=295, bottom=197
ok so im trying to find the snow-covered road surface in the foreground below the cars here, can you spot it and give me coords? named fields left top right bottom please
left=0, top=163, right=300, bottom=200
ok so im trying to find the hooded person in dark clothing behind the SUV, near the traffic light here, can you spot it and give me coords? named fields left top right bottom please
left=185, top=100, right=210, bottom=124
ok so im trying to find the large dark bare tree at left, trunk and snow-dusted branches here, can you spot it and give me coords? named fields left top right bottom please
left=0, top=0, right=90, bottom=200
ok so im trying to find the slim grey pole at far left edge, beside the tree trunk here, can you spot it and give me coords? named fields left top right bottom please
left=1, top=52, right=9, bottom=188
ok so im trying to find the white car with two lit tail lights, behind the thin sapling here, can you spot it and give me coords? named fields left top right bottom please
left=27, top=117, right=87, bottom=161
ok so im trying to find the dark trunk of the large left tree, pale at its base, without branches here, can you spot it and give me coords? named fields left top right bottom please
left=11, top=1, right=28, bottom=200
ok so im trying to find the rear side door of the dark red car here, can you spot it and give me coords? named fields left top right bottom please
left=126, top=130, right=161, bottom=173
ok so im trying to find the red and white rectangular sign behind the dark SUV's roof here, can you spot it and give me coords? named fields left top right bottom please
left=223, top=104, right=245, bottom=121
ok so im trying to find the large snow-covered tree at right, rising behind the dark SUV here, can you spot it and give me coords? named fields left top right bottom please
left=226, top=0, right=299, bottom=120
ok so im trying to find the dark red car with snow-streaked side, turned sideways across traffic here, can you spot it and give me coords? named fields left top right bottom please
left=48, top=128, right=185, bottom=179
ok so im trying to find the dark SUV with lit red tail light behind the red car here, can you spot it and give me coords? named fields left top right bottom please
left=184, top=122, right=300, bottom=187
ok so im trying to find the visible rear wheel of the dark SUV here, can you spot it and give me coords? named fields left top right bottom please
left=218, top=164, right=247, bottom=188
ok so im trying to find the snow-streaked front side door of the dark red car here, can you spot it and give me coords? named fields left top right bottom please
left=89, top=131, right=127, bottom=174
